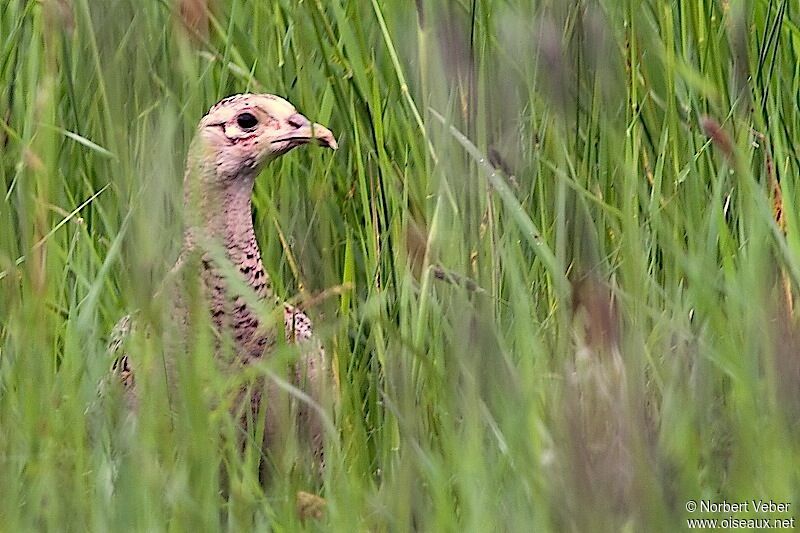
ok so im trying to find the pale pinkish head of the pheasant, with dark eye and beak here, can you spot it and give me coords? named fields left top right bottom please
left=193, top=94, right=337, bottom=179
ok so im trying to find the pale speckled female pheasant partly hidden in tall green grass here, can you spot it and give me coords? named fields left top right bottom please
left=110, top=94, right=337, bottom=465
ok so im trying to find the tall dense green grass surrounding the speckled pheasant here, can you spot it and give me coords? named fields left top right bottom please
left=0, top=0, right=800, bottom=531
